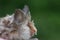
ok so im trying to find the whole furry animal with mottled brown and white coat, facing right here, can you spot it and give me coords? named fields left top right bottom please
left=0, top=5, right=38, bottom=40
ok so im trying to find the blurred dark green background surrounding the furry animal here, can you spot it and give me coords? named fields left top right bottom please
left=0, top=0, right=60, bottom=40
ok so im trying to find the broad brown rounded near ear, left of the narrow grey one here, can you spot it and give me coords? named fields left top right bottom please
left=14, top=9, right=24, bottom=22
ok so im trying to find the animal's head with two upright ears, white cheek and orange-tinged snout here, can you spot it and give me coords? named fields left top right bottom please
left=11, top=5, right=37, bottom=40
